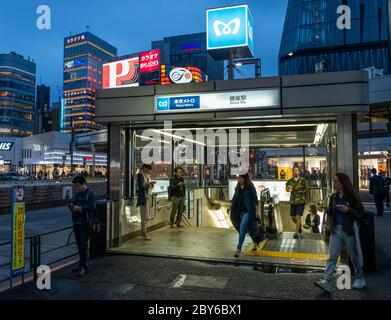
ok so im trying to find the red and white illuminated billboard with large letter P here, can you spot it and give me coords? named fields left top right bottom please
left=103, top=57, right=140, bottom=89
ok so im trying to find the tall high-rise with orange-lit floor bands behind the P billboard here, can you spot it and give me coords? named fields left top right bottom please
left=61, top=32, right=117, bottom=132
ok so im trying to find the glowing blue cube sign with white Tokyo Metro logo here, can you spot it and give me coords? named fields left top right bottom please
left=206, top=5, right=254, bottom=58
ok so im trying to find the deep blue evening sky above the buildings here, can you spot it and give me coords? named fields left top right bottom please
left=0, top=0, right=288, bottom=101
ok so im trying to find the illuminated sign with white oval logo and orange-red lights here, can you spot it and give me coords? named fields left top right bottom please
left=160, top=65, right=208, bottom=84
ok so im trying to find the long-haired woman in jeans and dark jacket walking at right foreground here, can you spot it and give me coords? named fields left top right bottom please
left=315, top=173, right=367, bottom=293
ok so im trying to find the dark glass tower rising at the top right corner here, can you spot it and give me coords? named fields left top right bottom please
left=279, top=0, right=390, bottom=75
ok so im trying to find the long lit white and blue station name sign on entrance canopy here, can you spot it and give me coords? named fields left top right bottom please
left=155, top=89, right=280, bottom=113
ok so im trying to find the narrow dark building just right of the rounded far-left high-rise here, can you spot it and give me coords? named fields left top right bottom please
left=35, top=84, right=51, bottom=134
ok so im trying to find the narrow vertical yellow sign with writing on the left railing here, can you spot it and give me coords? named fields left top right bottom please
left=12, top=202, right=25, bottom=274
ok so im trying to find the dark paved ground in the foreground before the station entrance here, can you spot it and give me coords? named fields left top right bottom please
left=0, top=204, right=391, bottom=300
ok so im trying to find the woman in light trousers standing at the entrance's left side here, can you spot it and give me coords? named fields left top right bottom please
left=137, top=164, right=154, bottom=241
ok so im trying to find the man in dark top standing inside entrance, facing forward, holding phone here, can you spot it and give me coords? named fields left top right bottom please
left=169, top=167, right=186, bottom=229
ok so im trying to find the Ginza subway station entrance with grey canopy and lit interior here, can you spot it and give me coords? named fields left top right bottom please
left=96, top=72, right=368, bottom=268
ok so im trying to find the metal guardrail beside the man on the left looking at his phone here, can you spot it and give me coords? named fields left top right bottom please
left=0, top=226, right=78, bottom=288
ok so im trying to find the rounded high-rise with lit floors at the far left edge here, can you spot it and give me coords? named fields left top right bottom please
left=0, top=52, right=36, bottom=137
